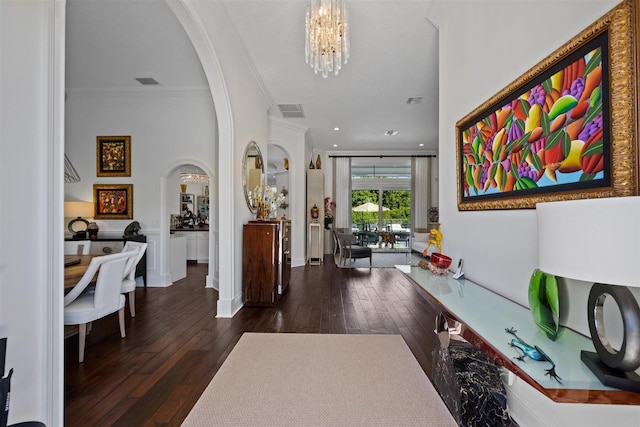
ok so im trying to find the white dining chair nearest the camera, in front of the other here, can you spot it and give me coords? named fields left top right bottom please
left=64, top=252, right=136, bottom=363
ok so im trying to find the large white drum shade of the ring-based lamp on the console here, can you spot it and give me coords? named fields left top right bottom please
left=536, top=197, right=640, bottom=287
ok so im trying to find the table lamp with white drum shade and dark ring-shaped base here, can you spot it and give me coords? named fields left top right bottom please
left=536, top=197, right=640, bottom=392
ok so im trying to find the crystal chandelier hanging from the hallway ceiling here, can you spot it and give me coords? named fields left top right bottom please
left=304, top=0, right=349, bottom=78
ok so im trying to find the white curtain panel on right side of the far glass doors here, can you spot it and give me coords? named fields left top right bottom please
left=411, top=157, right=431, bottom=230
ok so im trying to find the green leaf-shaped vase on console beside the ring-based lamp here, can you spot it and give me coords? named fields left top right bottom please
left=529, top=269, right=564, bottom=341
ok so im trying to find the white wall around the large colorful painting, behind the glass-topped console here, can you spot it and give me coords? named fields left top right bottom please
left=429, top=0, right=640, bottom=426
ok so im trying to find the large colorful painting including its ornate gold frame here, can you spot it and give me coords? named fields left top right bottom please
left=456, top=1, right=638, bottom=210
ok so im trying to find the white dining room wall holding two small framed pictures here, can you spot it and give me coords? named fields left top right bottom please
left=65, top=88, right=217, bottom=286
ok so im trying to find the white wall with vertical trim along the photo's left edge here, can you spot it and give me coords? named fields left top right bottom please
left=0, top=0, right=64, bottom=426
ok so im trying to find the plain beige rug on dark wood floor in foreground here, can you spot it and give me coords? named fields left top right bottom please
left=182, top=333, right=456, bottom=426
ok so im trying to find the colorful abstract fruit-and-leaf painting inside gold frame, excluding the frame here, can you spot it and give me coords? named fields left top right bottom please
left=459, top=34, right=610, bottom=207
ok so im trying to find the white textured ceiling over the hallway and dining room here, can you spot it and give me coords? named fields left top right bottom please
left=67, top=0, right=438, bottom=152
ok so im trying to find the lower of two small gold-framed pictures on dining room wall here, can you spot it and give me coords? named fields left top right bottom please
left=93, top=184, right=133, bottom=219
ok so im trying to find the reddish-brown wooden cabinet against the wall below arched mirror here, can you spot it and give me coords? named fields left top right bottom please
left=242, top=221, right=291, bottom=306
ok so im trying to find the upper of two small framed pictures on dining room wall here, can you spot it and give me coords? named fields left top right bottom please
left=96, top=136, right=131, bottom=177
